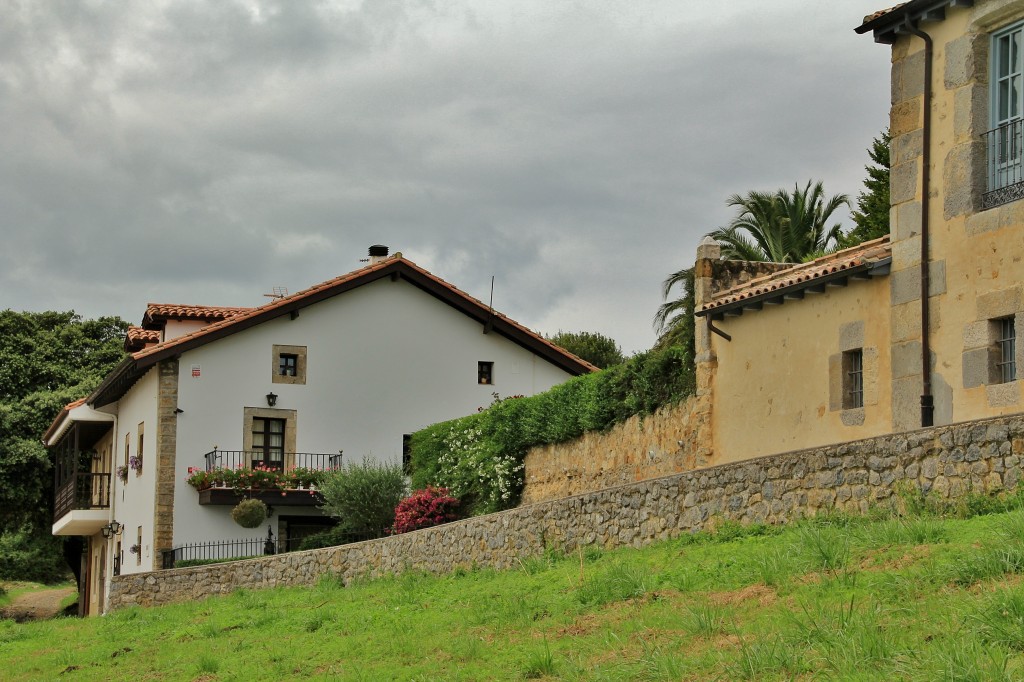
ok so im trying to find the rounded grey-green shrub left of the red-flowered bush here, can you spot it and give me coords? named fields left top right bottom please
left=319, top=458, right=406, bottom=538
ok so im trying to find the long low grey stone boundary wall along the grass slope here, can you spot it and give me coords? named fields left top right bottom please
left=109, top=415, right=1024, bottom=609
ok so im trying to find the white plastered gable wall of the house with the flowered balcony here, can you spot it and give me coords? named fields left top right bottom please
left=163, top=280, right=570, bottom=545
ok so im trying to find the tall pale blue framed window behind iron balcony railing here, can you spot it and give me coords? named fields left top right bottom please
left=984, top=24, right=1024, bottom=208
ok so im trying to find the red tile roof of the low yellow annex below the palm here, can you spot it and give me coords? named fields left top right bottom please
left=697, top=237, right=892, bottom=314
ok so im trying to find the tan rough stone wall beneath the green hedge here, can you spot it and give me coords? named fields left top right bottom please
left=522, top=396, right=712, bottom=504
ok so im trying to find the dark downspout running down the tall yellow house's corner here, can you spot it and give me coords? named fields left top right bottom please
left=903, top=17, right=935, bottom=427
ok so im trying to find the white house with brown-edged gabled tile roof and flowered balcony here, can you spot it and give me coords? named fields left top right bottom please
left=44, top=247, right=595, bottom=613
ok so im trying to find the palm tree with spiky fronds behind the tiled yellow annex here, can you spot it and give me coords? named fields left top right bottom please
left=710, top=180, right=850, bottom=263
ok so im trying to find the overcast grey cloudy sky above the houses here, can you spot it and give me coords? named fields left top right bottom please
left=0, top=0, right=893, bottom=351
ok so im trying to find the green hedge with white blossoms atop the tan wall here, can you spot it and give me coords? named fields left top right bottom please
left=412, top=346, right=694, bottom=514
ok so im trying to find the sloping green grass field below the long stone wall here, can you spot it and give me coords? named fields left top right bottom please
left=6, top=505, right=1024, bottom=681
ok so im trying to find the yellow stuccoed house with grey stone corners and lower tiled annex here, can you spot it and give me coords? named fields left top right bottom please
left=695, top=0, right=1024, bottom=463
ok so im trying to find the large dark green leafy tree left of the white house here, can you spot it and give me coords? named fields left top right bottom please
left=0, top=310, right=128, bottom=580
